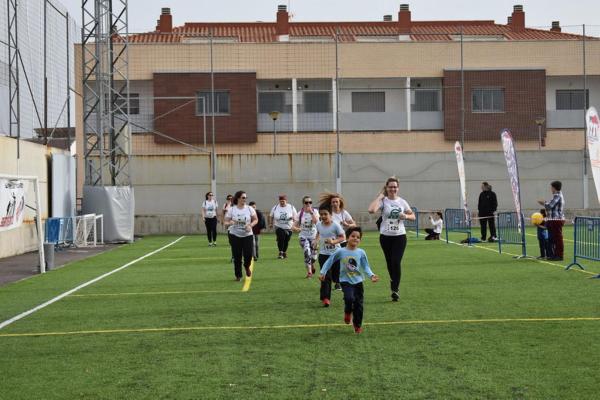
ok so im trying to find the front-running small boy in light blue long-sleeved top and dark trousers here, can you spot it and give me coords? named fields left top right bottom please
left=319, top=226, right=379, bottom=333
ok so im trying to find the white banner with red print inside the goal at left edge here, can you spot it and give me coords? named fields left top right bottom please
left=0, top=178, right=27, bottom=232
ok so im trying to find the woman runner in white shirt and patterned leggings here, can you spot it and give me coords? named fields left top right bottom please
left=294, top=196, right=319, bottom=278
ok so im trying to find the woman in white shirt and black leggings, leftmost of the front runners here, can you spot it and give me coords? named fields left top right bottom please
left=224, top=190, right=258, bottom=281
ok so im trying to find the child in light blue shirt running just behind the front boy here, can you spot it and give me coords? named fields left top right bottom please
left=315, top=204, right=346, bottom=307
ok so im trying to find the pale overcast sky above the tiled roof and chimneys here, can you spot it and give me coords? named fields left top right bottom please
left=59, top=0, right=600, bottom=32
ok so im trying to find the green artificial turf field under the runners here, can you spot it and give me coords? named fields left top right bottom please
left=0, top=227, right=600, bottom=400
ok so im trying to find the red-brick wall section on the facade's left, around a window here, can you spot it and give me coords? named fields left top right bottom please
left=154, top=72, right=257, bottom=144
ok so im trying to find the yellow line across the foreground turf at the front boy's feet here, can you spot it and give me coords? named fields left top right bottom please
left=0, top=317, right=600, bottom=337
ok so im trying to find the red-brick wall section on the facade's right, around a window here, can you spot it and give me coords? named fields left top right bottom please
left=444, top=70, right=546, bottom=140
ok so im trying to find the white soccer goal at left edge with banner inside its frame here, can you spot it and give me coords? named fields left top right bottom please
left=0, top=174, right=46, bottom=273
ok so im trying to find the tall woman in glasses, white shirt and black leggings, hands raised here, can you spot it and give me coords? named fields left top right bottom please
left=369, top=177, right=415, bottom=301
